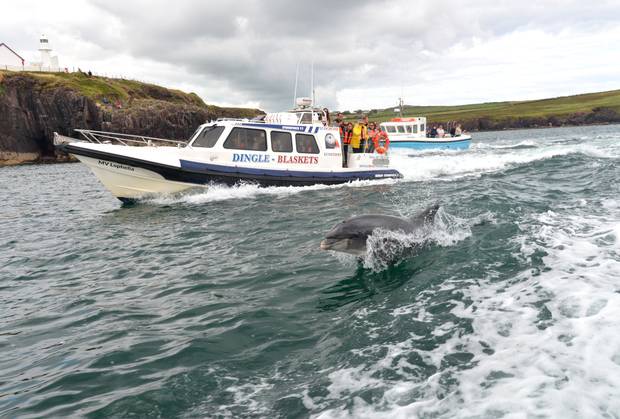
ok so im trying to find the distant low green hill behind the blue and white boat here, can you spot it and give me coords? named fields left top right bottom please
left=347, top=90, right=620, bottom=129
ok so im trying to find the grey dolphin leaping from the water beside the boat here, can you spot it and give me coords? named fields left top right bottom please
left=321, top=204, right=439, bottom=257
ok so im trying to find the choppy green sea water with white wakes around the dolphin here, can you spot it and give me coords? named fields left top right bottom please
left=0, top=125, right=620, bottom=418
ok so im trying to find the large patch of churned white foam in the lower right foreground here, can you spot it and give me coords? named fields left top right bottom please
left=312, top=200, right=620, bottom=418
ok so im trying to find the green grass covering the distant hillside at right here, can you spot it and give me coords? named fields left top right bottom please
left=351, top=90, right=620, bottom=122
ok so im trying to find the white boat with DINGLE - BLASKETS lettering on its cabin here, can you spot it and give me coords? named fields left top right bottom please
left=54, top=108, right=402, bottom=202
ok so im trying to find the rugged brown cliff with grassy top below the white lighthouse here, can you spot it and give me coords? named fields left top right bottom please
left=0, top=71, right=262, bottom=165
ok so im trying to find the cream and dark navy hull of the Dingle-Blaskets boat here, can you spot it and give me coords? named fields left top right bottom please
left=60, top=144, right=402, bottom=202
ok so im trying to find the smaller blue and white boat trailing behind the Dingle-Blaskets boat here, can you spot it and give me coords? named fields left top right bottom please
left=380, top=117, right=471, bottom=150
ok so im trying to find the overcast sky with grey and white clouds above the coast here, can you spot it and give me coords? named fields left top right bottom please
left=0, top=0, right=620, bottom=111
